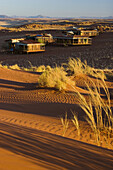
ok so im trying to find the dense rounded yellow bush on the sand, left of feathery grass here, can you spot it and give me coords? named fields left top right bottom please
left=38, top=66, right=75, bottom=91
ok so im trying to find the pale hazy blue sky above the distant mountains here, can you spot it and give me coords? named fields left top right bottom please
left=0, top=0, right=113, bottom=17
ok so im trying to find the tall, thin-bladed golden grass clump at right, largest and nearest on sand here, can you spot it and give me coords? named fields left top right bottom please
left=73, top=79, right=113, bottom=147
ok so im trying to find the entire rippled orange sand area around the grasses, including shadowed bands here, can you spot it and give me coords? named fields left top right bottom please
left=0, top=68, right=113, bottom=170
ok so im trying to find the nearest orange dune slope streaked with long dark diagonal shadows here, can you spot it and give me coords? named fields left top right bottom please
left=0, top=122, right=113, bottom=169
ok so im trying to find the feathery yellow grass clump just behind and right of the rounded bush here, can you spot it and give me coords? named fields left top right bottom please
left=65, top=58, right=106, bottom=79
